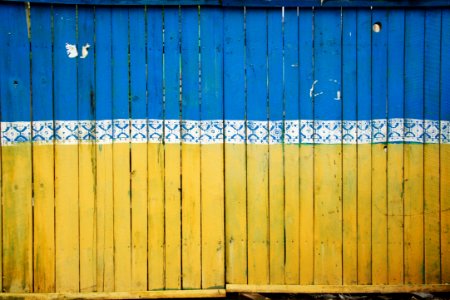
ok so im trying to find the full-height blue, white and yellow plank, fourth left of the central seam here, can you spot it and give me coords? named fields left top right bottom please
left=147, top=7, right=165, bottom=290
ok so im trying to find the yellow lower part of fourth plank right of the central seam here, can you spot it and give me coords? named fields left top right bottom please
left=284, top=145, right=303, bottom=284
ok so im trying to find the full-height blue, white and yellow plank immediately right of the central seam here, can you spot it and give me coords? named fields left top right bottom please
left=224, top=8, right=247, bottom=284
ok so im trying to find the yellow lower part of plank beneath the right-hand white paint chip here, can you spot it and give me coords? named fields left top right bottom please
left=79, top=143, right=97, bottom=292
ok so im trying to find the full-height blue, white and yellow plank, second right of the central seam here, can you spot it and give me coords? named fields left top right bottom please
left=246, top=8, right=269, bottom=284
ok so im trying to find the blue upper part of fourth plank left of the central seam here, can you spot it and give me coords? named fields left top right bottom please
left=147, top=7, right=163, bottom=119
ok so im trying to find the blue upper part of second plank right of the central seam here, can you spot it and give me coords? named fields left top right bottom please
left=246, top=8, right=267, bottom=121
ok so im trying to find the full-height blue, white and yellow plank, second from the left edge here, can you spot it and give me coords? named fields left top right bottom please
left=31, top=5, right=55, bottom=292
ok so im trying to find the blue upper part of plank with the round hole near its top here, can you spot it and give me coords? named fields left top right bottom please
left=367, top=9, right=389, bottom=123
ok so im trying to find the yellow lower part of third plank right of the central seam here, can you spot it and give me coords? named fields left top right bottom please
left=269, top=145, right=284, bottom=284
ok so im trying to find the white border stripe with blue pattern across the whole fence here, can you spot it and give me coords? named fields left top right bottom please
left=0, top=118, right=450, bottom=146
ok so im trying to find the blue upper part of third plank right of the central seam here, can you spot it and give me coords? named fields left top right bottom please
left=268, top=9, right=284, bottom=121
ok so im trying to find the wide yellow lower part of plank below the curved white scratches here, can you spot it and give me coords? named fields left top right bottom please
left=314, top=145, right=342, bottom=284
